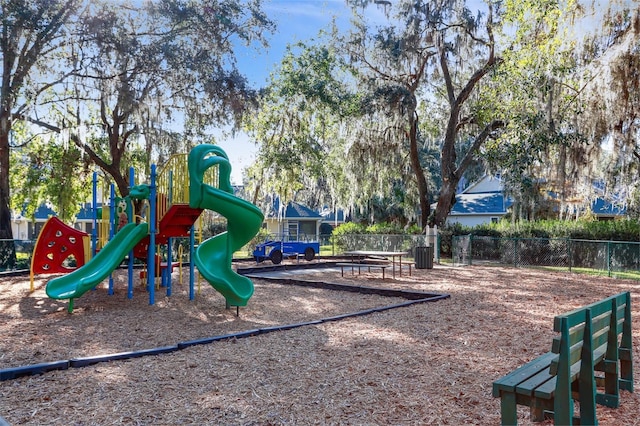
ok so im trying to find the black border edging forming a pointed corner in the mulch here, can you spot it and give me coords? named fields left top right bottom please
left=0, top=263, right=451, bottom=382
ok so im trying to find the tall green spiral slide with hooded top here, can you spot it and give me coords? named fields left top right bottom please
left=189, top=144, right=264, bottom=306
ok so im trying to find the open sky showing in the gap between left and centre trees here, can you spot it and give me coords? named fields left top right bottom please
left=218, top=0, right=382, bottom=184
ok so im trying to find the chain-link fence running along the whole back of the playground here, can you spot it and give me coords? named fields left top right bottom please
left=8, top=234, right=640, bottom=279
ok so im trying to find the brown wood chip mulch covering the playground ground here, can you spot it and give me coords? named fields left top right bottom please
left=0, top=265, right=640, bottom=426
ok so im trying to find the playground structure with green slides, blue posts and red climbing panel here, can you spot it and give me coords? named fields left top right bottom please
left=32, top=144, right=263, bottom=312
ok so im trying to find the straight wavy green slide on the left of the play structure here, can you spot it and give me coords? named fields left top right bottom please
left=46, top=223, right=149, bottom=312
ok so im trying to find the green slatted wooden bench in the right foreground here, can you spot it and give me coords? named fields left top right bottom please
left=493, top=292, right=633, bottom=425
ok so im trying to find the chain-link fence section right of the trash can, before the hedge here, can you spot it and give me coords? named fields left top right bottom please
left=452, top=235, right=640, bottom=278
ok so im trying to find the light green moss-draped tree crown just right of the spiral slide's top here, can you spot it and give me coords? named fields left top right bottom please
left=244, top=43, right=355, bottom=211
